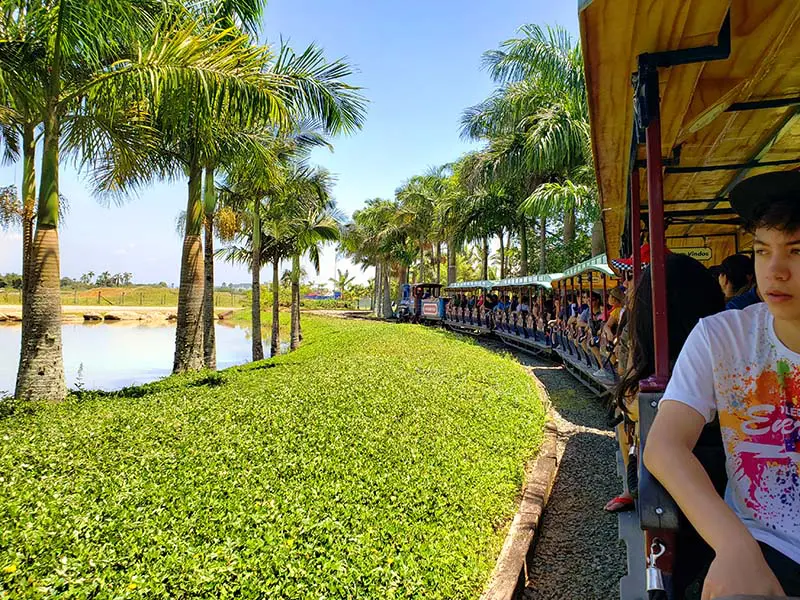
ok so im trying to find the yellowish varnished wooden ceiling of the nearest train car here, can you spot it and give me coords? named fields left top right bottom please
left=579, top=0, right=800, bottom=264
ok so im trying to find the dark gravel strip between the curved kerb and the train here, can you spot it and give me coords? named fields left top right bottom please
left=478, top=341, right=626, bottom=600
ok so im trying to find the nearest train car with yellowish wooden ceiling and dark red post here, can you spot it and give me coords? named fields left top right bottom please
left=579, top=0, right=800, bottom=600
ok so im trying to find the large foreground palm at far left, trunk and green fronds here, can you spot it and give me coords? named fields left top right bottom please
left=0, top=0, right=290, bottom=399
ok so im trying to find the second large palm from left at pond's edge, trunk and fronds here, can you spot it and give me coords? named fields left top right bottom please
left=90, top=28, right=364, bottom=372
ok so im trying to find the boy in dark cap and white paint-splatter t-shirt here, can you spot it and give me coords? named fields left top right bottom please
left=644, top=171, right=800, bottom=599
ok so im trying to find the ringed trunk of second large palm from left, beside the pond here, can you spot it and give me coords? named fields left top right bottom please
left=172, top=160, right=205, bottom=373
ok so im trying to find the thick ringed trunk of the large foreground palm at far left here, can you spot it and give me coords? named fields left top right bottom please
left=15, top=102, right=67, bottom=400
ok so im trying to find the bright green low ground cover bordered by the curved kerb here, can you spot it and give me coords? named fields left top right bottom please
left=0, top=317, right=544, bottom=600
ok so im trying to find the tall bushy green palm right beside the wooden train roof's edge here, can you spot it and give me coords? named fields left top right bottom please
left=462, top=25, right=598, bottom=264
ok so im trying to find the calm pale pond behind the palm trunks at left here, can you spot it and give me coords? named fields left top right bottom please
left=0, top=321, right=269, bottom=397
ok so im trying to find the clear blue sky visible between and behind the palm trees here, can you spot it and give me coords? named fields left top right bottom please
left=0, top=0, right=578, bottom=284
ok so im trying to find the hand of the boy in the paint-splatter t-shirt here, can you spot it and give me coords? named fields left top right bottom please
left=702, top=544, right=786, bottom=600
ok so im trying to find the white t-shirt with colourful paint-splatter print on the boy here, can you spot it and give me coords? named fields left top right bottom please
left=664, top=303, right=800, bottom=563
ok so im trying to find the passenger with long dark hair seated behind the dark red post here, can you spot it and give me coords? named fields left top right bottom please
left=605, top=254, right=725, bottom=512
